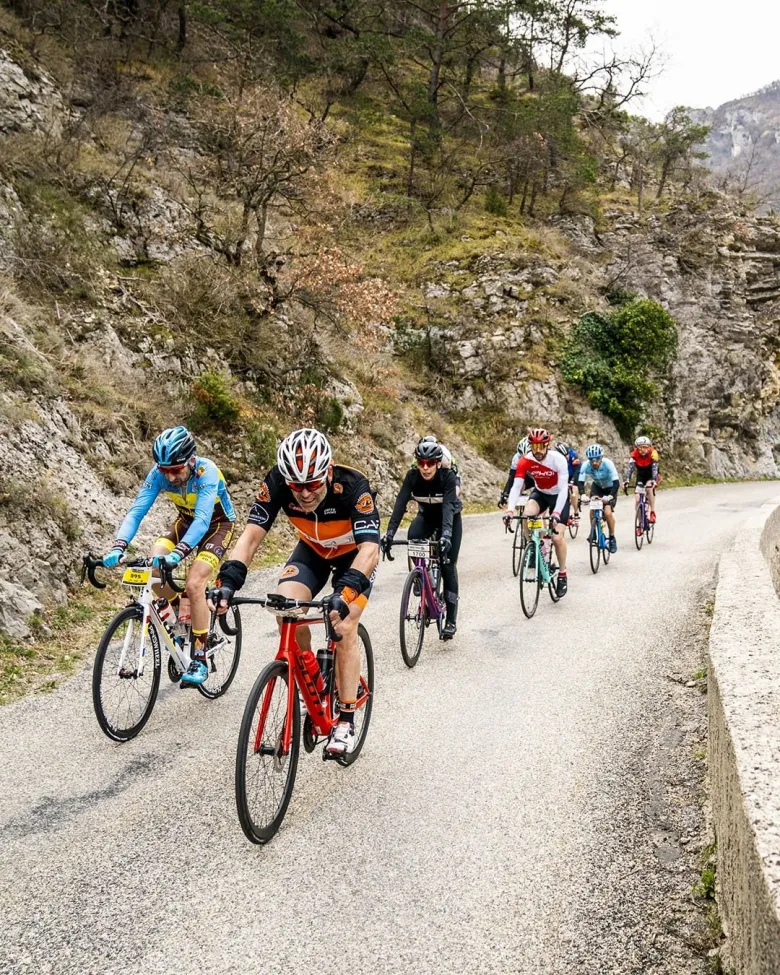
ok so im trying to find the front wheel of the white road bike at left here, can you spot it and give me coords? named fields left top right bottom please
left=92, top=605, right=162, bottom=741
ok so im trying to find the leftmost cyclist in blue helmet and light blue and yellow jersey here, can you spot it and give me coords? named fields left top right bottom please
left=103, top=426, right=236, bottom=687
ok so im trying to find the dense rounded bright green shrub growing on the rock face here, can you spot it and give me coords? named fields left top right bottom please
left=561, top=298, right=677, bottom=440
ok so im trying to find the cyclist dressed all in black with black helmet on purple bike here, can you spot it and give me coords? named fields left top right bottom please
left=382, top=439, right=463, bottom=640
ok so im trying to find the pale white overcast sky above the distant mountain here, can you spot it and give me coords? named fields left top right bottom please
left=588, top=0, right=780, bottom=120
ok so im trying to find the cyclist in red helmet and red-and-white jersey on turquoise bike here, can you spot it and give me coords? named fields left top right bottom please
left=509, top=427, right=569, bottom=597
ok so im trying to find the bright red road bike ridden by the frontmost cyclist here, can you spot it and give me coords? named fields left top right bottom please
left=231, top=593, right=374, bottom=843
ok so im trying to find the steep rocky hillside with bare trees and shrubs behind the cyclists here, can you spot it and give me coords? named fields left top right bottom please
left=0, top=0, right=780, bottom=694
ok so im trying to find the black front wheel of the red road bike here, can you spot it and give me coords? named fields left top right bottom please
left=235, top=660, right=301, bottom=844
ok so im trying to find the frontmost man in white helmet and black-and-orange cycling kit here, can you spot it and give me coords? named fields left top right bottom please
left=207, top=427, right=379, bottom=755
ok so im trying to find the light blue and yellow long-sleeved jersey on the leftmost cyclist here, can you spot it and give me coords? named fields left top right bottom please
left=116, top=457, right=236, bottom=551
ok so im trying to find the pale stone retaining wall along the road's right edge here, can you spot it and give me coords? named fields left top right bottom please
left=709, top=499, right=780, bottom=975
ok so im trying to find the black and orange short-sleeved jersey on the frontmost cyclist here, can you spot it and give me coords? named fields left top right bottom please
left=249, top=466, right=379, bottom=559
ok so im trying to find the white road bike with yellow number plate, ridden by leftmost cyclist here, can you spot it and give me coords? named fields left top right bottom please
left=82, top=555, right=241, bottom=741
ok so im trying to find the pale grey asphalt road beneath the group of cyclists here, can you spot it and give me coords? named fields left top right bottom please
left=0, top=483, right=777, bottom=975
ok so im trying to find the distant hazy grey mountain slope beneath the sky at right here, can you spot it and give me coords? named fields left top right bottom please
left=691, top=80, right=780, bottom=210
